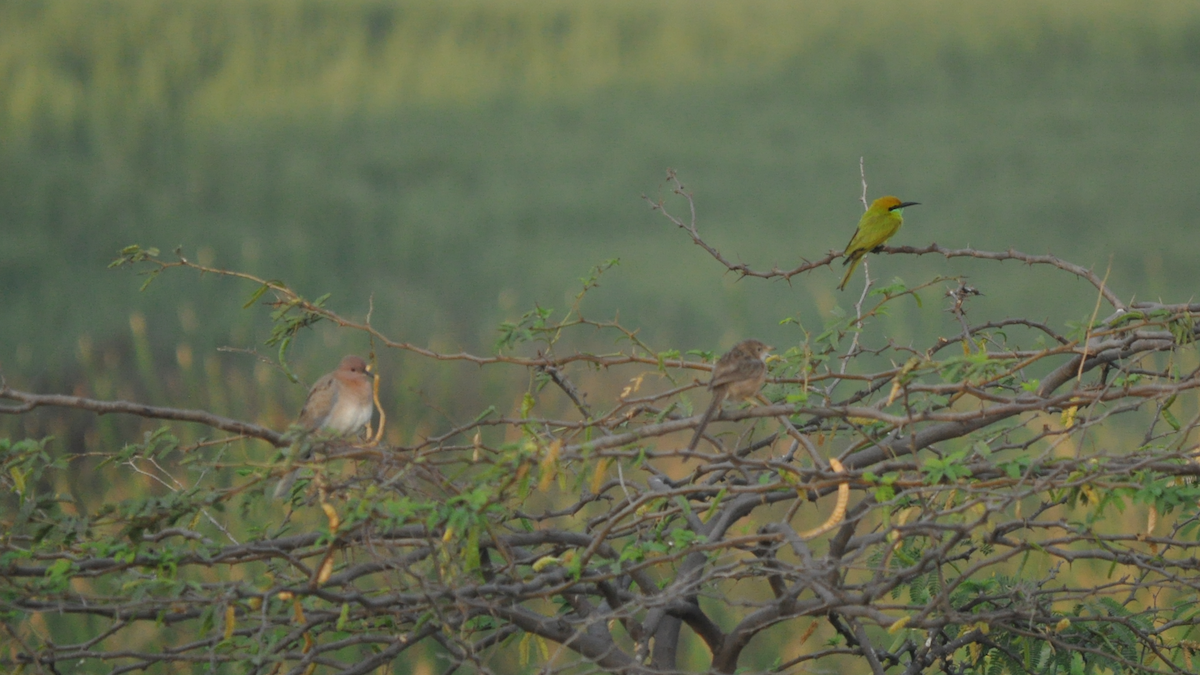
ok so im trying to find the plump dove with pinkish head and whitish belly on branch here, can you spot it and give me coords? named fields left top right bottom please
left=275, top=354, right=374, bottom=497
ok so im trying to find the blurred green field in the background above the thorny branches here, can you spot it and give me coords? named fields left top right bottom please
left=0, top=0, right=1200, bottom=389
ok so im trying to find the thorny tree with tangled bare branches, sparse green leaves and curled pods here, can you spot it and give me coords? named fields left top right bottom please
left=0, top=177, right=1200, bottom=675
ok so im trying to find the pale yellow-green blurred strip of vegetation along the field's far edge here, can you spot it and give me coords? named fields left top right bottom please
left=7, top=0, right=1200, bottom=136
